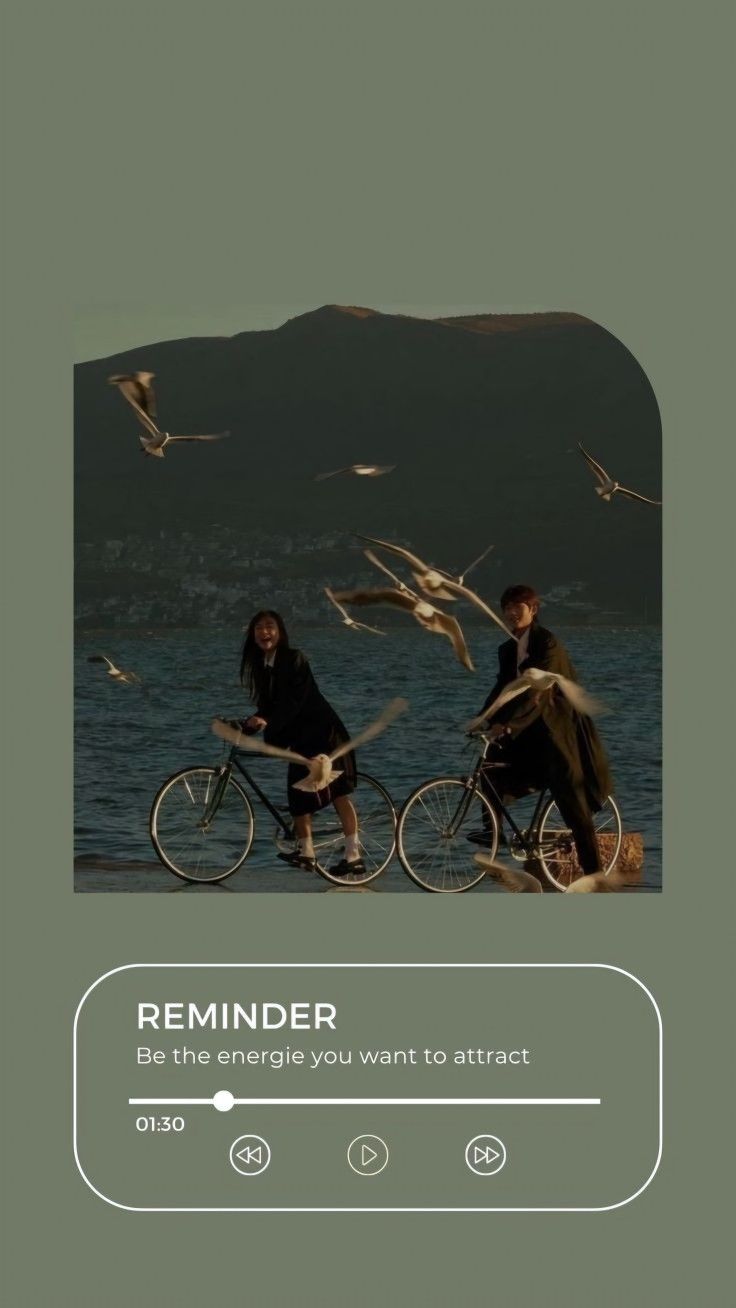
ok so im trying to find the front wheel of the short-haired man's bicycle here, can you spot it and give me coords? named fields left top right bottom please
left=396, top=777, right=498, bottom=893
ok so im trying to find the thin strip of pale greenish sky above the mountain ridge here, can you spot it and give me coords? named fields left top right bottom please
left=75, top=303, right=546, bottom=364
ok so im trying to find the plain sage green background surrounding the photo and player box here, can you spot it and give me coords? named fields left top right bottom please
left=1, top=0, right=733, bottom=1308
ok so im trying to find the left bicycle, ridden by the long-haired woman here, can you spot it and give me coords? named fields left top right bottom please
left=149, top=727, right=396, bottom=886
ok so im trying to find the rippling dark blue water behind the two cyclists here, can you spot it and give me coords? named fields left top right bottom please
left=75, top=627, right=661, bottom=893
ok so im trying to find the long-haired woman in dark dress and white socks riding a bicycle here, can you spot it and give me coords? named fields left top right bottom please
left=241, top=610, right=365, bottom=872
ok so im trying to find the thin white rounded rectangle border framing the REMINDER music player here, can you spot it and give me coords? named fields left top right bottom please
left=72, top=963, right=663, bottom=1213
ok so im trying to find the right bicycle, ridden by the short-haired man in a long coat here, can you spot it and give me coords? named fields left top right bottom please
left=396, top=731, right=621, bottom=893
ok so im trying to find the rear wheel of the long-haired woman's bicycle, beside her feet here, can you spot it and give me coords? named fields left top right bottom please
left=312, top=772, right=396, bottom=886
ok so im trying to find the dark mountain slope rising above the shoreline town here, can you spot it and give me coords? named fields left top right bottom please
left=75, top=305, right=661, bottom=621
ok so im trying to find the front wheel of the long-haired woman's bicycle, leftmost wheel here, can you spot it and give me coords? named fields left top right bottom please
left=149, top=768, right=255, bottom=882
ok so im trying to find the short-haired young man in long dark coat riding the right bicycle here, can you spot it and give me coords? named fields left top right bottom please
left=475, top=586, right=611, bottom=872
